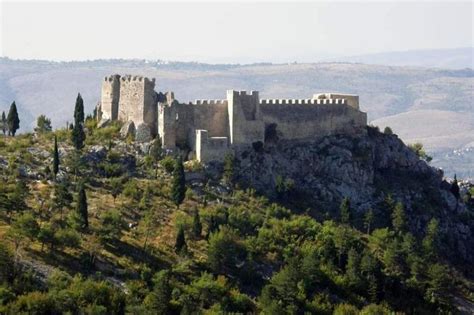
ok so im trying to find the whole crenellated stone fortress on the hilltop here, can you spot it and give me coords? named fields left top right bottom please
left=97, top=75, right=367, bottom=162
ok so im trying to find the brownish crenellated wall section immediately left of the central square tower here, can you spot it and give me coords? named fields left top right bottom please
left=192, top=100, right=229, bottom=137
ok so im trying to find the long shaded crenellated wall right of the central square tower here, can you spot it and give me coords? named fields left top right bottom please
left=260, top=104, right=367, bottom=140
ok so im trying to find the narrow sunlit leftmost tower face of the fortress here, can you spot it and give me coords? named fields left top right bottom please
left=100, top=74, right=120, bottom=120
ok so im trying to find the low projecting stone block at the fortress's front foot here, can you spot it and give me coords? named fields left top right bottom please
left=195, top=129, right=229, bottom=163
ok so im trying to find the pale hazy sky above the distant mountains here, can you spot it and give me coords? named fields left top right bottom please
left=0, top=0, right=473, bottom=63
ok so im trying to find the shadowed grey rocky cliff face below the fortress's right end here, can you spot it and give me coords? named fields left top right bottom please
left=231, top=128, right=474, bottom=263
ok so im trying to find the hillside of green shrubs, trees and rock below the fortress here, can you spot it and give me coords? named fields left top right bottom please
left=0, top=98, right=474, bottom=314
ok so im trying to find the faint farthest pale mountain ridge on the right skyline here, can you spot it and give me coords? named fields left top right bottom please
left=327, top=47, right=474, bottom=69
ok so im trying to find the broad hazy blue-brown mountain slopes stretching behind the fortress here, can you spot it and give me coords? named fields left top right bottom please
left=0, top=53, right=474, bottom=178
